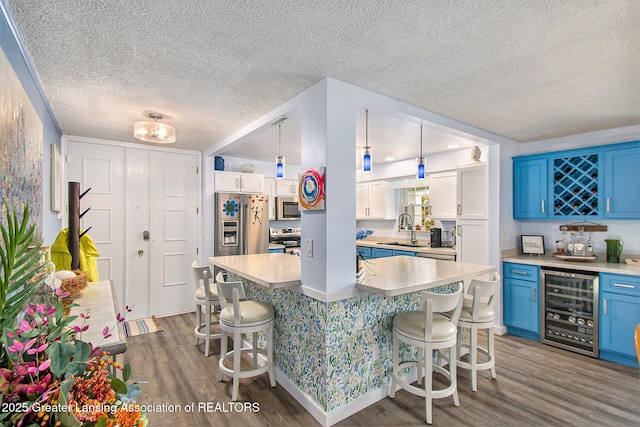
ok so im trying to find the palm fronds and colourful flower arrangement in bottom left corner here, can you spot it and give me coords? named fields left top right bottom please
left=0, top=208, right=146, bottom=427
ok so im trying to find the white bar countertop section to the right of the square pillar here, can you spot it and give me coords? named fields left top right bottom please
left=356, top=256, right=496, bottom=296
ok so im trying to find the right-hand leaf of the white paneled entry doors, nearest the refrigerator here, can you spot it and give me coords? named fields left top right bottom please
left=150, top=152, right=199, bottom=316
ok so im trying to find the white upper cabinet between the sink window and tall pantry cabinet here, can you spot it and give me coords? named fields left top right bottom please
left=458, top=163, right=489, bottom=219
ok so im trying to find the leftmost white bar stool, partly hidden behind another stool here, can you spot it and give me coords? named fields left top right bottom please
left=191, top=261, right=220, bottom=357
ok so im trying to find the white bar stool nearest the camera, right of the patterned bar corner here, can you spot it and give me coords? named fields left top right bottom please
left=389, top=286, right=463, bottom=424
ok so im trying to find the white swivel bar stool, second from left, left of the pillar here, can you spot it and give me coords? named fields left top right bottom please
left=216, top=273, right=276, bottom=402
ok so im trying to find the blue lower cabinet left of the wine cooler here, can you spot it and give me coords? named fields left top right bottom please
left=503, top=263, right=540, bottom=341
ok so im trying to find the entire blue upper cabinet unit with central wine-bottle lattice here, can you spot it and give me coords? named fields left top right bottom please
left=513, top=141, right=640, bottom=220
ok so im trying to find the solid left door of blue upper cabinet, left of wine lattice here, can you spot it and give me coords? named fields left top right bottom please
left=513, top=157, right=548, bottom=219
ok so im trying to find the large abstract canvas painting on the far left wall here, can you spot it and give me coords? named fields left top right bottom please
left=0, top=49, right=43, bottom=236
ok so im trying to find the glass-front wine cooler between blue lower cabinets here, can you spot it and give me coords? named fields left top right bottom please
left=540, top=269, right=598, bottom=357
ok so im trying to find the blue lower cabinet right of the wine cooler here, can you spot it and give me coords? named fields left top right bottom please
left=599, top=273, right=640, bottom=367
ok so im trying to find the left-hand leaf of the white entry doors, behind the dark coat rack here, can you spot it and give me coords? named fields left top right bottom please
left=65, top=141, right=125, bottom=309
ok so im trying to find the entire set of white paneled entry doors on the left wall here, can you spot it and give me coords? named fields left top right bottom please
left=67, top=140, right=199, bottom=320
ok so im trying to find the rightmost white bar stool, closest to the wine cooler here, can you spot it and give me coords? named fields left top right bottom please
left=457, top=273, right=501, bottom=391
